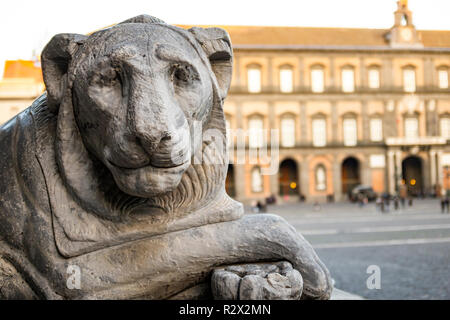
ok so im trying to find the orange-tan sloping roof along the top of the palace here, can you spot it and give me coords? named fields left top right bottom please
left=179, top=25, right=450, bottom=48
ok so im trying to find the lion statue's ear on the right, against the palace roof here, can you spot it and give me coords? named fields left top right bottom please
left=189, top=27, right=233, bottom=99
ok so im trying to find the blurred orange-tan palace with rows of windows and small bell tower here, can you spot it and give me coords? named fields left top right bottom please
left=215, top=1, right=450, bottom=203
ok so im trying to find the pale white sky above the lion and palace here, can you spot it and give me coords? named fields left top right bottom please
left=0, top=0, right=450, bottom=75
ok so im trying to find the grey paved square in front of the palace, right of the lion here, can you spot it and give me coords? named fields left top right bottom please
left=246, top=199, right=450, bottom=299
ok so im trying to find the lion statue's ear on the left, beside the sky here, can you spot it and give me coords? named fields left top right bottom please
left=41, top=33, right=87, bottom=108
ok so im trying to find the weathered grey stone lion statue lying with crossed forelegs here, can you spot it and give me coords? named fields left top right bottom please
left=0, top=15, right=332, bottom=299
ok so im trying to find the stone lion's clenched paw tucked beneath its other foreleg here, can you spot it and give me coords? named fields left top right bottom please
left=211, top=261, right=303, bottom=300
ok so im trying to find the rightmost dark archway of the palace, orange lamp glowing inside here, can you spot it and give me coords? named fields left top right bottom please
left=402, top=156, right=423, bottom=197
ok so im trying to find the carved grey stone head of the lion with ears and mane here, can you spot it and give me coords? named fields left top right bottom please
left=42, top=16, right=236, bottom=218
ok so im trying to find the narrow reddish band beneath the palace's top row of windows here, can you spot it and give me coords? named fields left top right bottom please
left=230, top=86, right=450, bottom=95
